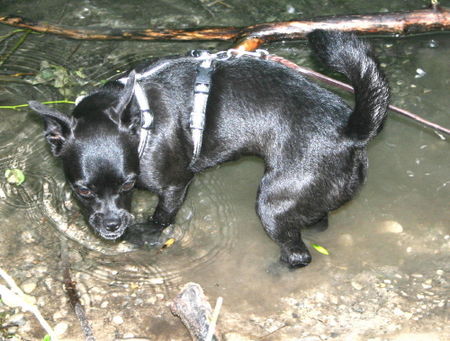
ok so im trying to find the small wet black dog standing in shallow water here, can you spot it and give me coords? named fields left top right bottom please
left=30, top=31, right=389, bottom=267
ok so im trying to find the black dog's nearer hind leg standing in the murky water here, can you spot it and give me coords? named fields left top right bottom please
left=257, top=172, right=328, bottom=268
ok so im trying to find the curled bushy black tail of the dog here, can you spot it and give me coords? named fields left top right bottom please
left=308, top=30, right=389, bottom=142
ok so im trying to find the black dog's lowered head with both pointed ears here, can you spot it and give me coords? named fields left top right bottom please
left=29, top=73, right=140, bottom=240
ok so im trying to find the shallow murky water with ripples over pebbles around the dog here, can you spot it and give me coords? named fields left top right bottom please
left=0, top=0, right=450, bottom=340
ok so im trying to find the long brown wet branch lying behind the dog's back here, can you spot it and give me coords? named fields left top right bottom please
left=0, top=6, right=450, bottom=44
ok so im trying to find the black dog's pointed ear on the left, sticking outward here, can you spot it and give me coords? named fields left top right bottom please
left=28, top=101, right=76, bottom=156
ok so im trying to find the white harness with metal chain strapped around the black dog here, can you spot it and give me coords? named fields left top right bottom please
left=76, top=49, right=268, bottom=165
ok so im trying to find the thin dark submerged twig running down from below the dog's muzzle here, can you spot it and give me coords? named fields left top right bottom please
left=60, top=237, right=95, bottom=341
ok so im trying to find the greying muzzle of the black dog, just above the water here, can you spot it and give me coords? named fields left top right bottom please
left=89, top=210, right=133, bottom=240
